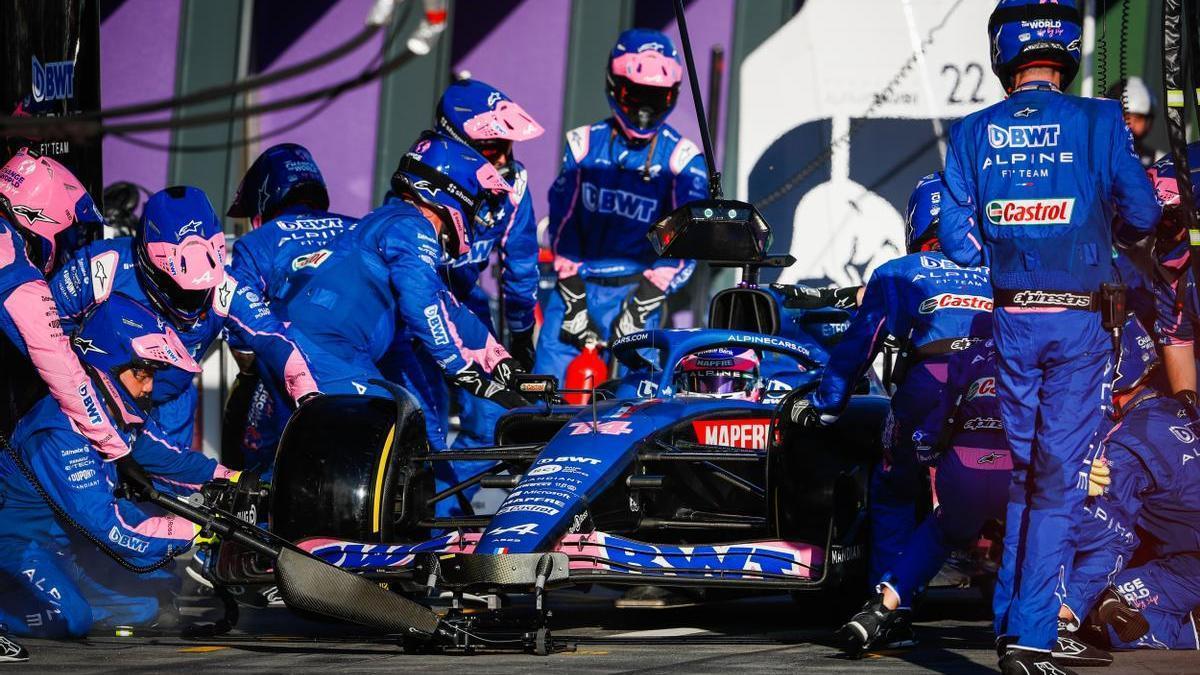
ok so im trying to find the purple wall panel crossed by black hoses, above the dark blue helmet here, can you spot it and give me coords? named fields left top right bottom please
left=248, top=0, right=383, bottom=216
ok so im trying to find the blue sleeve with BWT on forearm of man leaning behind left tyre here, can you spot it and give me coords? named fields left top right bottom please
left=376, top=217, right=491, bottom=375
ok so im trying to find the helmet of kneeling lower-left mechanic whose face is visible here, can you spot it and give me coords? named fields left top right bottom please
left=71, top=293, right=200, bottom=428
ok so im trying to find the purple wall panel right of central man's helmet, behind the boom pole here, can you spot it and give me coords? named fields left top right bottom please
left=664, top=0, right=734, bottom=170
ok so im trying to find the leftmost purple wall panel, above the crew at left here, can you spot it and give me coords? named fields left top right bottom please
left=97, top=0, right=181, bottom=189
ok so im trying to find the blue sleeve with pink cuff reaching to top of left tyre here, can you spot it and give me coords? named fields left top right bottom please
left=215, top=264, right=317, bottom=400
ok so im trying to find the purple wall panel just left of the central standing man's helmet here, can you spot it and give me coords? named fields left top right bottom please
left=451, top=0, right=571, bottom=219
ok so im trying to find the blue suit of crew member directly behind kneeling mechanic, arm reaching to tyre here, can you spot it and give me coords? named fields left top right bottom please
left=50, top=237, right=317, bottom=448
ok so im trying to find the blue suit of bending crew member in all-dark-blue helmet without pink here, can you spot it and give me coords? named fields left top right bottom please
left=228, top=207, right=362, bottom=468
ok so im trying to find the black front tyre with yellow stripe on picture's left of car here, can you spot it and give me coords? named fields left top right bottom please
left=270, top=393, right=428, bottom=543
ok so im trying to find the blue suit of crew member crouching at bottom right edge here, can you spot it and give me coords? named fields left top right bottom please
left=1062, top=389, right=1200, bottom=650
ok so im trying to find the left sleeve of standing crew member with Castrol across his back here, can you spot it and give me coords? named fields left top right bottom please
left=937, top=121, right=984, bottom=267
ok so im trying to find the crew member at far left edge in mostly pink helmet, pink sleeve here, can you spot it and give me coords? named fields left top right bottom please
left=0, top=148, right=130, bottom=459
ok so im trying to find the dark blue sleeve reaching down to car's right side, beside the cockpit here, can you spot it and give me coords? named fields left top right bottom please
left=812, top=267, right=895, bottom=416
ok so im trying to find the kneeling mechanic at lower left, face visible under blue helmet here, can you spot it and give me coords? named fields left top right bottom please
left=0, top=295, right=199, bottom=638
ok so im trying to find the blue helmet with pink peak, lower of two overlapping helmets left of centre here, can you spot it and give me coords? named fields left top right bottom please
left=391, top=131, right=512, bottom=258
